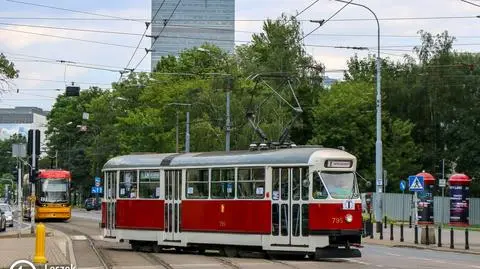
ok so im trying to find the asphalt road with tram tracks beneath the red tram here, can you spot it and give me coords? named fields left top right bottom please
left=54, top=211, right=480, bottom=269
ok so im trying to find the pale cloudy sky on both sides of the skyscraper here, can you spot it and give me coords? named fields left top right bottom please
left=0, top=0, right=480, bottom=110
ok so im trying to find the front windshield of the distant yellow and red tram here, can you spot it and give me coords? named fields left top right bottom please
left=39, top=178, right=69, bottom=203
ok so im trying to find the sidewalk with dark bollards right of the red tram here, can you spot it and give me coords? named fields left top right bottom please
left=362, top=224, right=480, bottom=255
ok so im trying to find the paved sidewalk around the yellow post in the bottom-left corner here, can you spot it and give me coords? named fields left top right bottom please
left=0, top=225, right=75, bottom=269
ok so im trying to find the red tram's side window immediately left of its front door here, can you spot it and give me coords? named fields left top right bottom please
left=237, top=167, right=265, bottom=199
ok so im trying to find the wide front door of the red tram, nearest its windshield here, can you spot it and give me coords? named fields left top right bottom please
left=271, top=167, right=310, bottom=246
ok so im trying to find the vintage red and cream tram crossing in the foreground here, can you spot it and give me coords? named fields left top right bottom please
left=101, top=147, right=362, bottom=258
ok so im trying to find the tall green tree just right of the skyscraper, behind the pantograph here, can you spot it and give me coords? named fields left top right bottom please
left=237, top=14, right=324, bottom=144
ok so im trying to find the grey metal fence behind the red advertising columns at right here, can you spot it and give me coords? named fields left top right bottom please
left=362, top=193, right=480, bottom=225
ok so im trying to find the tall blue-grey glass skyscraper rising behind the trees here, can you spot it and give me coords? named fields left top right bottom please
left=151, top=0, right=235, bottom=71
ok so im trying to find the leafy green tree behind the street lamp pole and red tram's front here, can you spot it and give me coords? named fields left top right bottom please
left=310, top=81, right=419, bottom=191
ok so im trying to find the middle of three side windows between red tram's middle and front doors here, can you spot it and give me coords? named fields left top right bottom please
left=210, top=168, right=235, bottom=199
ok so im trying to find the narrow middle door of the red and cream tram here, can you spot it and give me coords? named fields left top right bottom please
left=164, top=170, right=182, bottom=242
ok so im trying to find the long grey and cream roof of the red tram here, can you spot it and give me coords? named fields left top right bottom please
left=103, top=147, right=354, bottom=169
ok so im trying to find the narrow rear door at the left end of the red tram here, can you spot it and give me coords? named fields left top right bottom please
left=104, top=171, right=117, bottom=237
